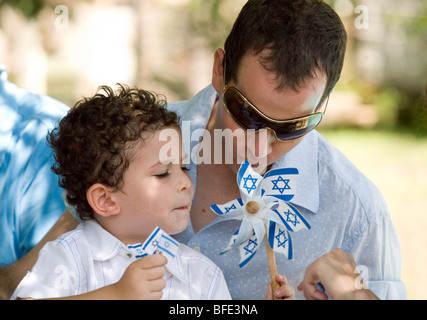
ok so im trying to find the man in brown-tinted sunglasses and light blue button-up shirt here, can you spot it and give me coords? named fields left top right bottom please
left=0, top=0, right=405, bottom=299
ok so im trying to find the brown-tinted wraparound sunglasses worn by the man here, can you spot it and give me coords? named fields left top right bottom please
left=222, top=85, right=329, bottom=141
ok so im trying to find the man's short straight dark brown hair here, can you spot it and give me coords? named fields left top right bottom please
left=224, top=0, right=347, bottom=101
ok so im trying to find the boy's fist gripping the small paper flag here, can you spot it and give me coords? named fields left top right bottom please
left=111, top=254, right=167, bottom=300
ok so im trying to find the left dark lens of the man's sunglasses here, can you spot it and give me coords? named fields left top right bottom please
left=224, top=88, right=265, bottom=130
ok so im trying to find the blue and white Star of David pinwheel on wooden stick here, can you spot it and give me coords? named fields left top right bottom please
left=211, top=161, right=311, bottom=296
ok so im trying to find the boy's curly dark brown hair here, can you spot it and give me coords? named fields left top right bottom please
left=48, top=84, right=179, bottom=220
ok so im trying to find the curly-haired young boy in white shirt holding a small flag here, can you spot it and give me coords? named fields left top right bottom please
left=12, top=85, right=293, bottom=299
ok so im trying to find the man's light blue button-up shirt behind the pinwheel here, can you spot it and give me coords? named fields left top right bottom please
left=169, top=86, right=406, bottom=299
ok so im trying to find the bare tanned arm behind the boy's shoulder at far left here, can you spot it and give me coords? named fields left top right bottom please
left=0, top=210, right=78, bottom=299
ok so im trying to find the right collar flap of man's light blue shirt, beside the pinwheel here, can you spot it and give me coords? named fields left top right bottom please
left=272, top=130, right=319, bottom=213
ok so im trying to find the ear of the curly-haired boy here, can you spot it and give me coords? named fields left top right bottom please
left=86, top=183, right=121, bottom=217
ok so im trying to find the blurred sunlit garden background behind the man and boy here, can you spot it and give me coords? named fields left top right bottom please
left=0, top=0, right=427, bottom=299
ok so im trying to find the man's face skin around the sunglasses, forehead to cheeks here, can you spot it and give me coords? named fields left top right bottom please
left=218, top=53, right=327, bottom=173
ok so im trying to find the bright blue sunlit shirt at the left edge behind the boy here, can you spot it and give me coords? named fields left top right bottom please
left=0, top=65, right=68, bottom=266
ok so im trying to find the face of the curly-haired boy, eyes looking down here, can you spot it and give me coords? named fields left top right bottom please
left=115, top=128, right=194, bottom=243
